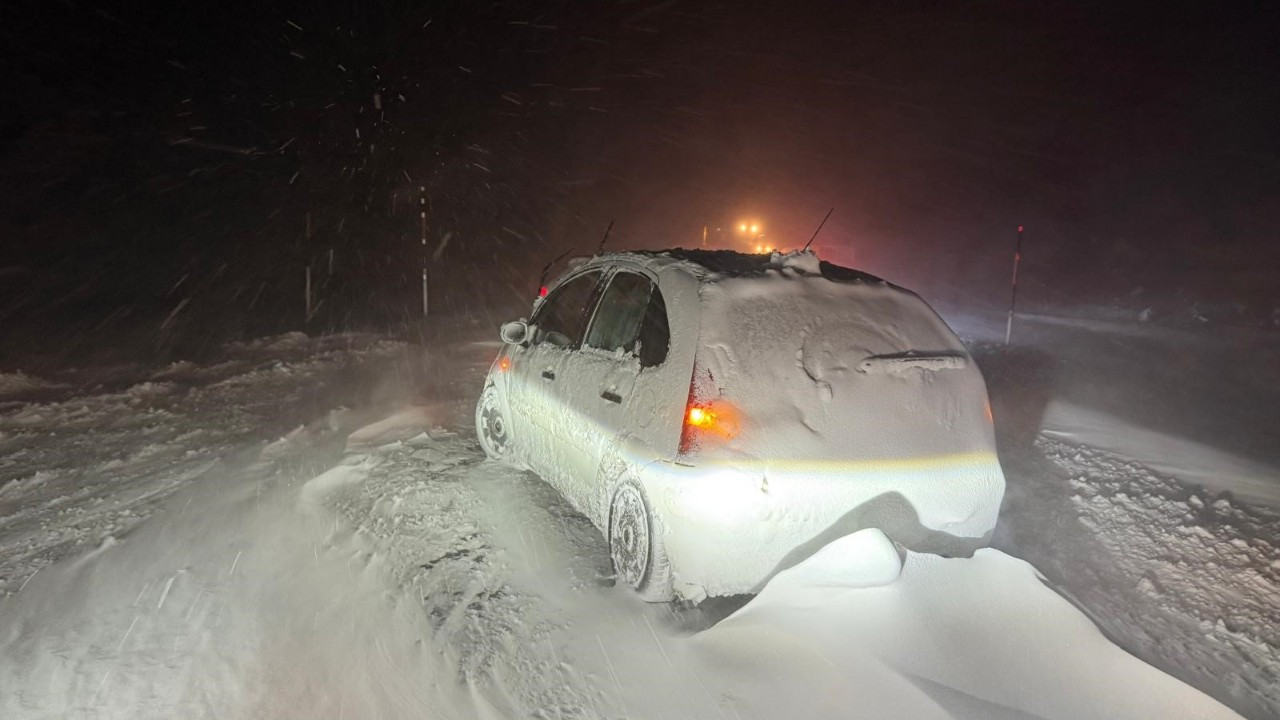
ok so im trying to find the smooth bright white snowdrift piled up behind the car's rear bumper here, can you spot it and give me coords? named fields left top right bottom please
left=694, top=530, right=1235, bottom=719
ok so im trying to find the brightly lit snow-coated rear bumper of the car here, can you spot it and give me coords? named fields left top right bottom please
left=640, top=452, right=1005, bottom=598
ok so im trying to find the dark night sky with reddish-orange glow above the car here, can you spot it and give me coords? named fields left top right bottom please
left=0, top=0, right=1280, bottom=358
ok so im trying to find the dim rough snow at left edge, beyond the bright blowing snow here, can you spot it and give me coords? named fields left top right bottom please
left=0, top=333, right=406, bottom=594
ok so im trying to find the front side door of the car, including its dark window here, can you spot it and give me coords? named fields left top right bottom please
left=509, top=268, right=602, bottom=484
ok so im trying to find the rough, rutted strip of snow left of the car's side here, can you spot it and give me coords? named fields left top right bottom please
left=316, top=432, right=613, bottom=720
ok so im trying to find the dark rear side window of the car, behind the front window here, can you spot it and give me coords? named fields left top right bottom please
left=585, top=272, right=671, bottom=368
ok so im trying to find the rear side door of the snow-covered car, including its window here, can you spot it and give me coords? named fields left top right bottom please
left=561, top=269, right=667, bottom=510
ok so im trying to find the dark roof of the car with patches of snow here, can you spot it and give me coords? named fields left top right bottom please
left=571, top=247, right=897, bottom=287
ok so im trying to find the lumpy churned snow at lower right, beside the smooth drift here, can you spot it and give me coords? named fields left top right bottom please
left=996, top=437, right=1280, bottom=717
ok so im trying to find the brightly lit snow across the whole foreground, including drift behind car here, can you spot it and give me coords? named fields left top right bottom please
left=3, top=404, right=1230, bottom=717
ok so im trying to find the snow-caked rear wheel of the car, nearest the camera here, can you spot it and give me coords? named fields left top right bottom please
left=609, top=480, right=673, bottom=602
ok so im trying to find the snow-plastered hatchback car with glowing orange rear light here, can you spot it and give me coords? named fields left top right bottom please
left=476, top=250, right=1005, bottom=601
